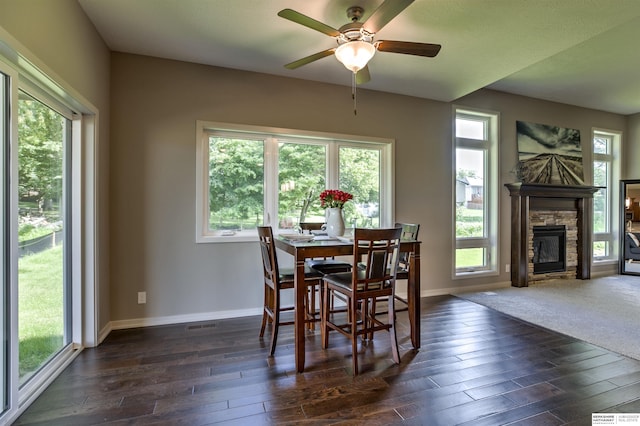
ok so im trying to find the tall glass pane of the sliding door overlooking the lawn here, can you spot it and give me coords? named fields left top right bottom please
left=17, top=92, right=71, bottom=385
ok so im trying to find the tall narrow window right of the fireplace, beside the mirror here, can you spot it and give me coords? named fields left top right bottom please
left=593, top=130, right=620, bottom=261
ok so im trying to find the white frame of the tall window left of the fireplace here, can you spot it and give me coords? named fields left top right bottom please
left=451, top=106, right=500, bottom=280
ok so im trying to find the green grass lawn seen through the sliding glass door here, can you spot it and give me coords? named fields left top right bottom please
left=18, top=245, right=64, bottom=378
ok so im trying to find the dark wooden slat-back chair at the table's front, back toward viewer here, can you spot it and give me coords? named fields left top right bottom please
left=320, top=228, right=402, bottom=376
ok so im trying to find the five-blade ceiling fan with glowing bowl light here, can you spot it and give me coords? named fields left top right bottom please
left=278, top=0, right=442, bottom=84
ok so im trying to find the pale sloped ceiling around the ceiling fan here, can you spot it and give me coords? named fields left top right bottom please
left=78, top=0, right=640, bottom=115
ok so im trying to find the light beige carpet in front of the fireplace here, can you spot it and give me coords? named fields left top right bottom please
left=454, top=275, right=640, bottom=360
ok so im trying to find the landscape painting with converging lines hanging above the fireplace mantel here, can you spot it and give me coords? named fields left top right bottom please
left=516, top=121, right=584, bottom=185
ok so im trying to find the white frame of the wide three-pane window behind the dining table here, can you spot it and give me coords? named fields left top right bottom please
left=195, top=120, right=395, bottom=244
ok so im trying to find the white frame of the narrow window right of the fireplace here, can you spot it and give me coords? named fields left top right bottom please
left=590, top=128, right=622, bottom=264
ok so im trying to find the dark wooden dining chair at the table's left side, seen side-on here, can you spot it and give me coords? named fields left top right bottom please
left=258, top=226, right=323, bottom=356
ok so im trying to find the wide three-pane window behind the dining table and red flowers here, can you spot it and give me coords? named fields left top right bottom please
left=196, top=122, right=393, bottom=242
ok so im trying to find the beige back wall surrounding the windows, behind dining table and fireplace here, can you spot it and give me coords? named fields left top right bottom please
left=110, top=53, right=626, bottom=321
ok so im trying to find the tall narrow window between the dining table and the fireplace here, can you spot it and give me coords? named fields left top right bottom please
left=453, top=109, right=498, bottom=276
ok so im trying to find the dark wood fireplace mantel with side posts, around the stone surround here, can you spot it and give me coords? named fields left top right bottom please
left=505, top=183, right=598, bottom=287
